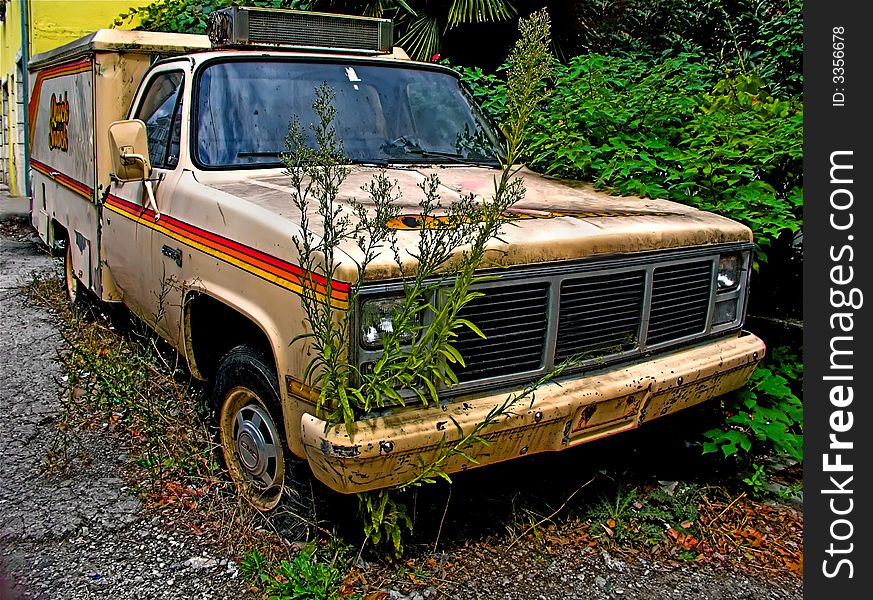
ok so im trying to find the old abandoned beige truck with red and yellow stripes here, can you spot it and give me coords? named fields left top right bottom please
left=29, top=7, right=765, bottom=510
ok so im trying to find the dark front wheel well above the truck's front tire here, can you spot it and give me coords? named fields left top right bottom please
left=185, top=293, right=276, bottom=379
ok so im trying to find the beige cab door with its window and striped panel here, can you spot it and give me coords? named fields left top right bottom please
left=102, top=65, right=185, bottom=337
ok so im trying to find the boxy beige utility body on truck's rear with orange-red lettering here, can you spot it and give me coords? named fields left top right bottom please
left=28, top=29, right=209, bottom=300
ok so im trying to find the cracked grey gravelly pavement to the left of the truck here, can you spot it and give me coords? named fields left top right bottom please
left=0, top=220, right=245, bottom=600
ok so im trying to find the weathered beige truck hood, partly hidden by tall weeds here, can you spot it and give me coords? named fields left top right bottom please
left=198, top=165, right=752, bottom=279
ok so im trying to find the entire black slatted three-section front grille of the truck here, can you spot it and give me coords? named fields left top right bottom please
left=446, top=257, right=714, bottom=389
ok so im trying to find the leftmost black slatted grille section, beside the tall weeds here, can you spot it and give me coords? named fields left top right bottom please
left=455, top=283, right=549, bottom=381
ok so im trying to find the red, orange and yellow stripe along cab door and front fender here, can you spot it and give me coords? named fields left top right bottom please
left=104, top=194, right=351, bottom=309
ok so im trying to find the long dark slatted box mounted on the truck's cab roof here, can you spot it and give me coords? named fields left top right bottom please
left=207, top=6, right=394, bottom=53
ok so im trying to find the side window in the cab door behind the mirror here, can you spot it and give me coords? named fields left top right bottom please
left=136, top=71, right=183, bottom=168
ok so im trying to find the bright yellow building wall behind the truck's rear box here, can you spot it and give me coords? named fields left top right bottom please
left=0, top=0, right=152, bottom=194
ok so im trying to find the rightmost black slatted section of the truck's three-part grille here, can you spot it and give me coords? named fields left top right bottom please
left=646, top=261, right=712, bottom=346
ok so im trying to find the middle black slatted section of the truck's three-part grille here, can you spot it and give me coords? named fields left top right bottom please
left=555, top=271, right=646, bottom=362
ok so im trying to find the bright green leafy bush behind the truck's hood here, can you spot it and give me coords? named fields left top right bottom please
left=463, top=54, right=803, bottom=260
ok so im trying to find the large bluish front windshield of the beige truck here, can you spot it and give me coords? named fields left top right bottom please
left=194, top=59, right=498, bottom=168
